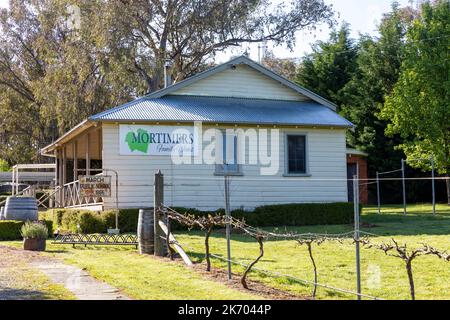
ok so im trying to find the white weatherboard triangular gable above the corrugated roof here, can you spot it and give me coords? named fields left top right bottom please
left=171, top=65, right=309, bottom=101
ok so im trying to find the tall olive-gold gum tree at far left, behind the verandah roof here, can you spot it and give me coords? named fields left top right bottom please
left=0, top=0, right=139, bottom=164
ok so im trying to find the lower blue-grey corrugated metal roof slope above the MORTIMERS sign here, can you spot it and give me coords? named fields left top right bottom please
left=89, top=95, right=352, bottom=127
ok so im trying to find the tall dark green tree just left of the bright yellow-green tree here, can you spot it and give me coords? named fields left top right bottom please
left=341, top=3, right=411, bottom=178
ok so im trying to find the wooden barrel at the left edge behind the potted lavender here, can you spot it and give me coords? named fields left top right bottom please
left=3, top=197, right=38, bottom=221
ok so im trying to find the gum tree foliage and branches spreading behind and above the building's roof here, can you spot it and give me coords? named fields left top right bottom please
left=0, top=0, right=333, bottom=164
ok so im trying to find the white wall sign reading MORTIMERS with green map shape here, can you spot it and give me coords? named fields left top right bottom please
left=119, top=124, right=196, bottom=156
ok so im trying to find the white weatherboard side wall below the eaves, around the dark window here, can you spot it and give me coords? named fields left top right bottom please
left=103, top=124, right=347, bottom=210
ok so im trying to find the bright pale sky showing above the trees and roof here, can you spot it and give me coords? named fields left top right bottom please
left=0, top=0, right=416, bottom=63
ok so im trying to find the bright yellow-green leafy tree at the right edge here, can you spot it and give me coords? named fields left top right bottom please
left=381, top=0, right=450, bottom=205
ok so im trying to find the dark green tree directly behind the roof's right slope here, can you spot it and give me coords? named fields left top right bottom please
left=296, top=23, right=357, bottom=105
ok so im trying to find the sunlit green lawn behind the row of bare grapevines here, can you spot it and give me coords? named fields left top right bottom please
left=177, top=205, right=450, bottom=299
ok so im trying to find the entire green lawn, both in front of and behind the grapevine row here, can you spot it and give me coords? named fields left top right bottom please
left=0, top=205, right=450, bottom=299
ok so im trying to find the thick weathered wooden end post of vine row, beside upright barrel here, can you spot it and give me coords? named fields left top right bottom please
left=153, top=170, right=167, bottom=257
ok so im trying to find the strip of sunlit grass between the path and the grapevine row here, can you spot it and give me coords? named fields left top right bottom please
left=0, top=240, right=261, bottom=300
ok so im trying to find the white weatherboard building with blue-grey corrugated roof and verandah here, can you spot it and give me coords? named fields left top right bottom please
left=42, top=56, right=352, bottom=210
